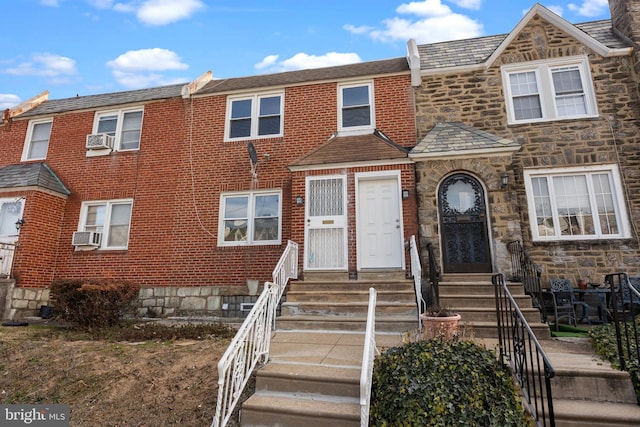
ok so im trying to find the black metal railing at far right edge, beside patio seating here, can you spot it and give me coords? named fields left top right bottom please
left=604, top=273, right=640, bottom=383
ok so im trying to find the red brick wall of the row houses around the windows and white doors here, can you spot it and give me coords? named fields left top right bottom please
left=0, top=74, right=415, bottom=316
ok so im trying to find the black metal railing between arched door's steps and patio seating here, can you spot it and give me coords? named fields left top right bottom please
left=507, top=240, right=547, bottom=323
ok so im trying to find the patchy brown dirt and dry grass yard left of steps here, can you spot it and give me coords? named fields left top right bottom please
left=0, top=326, right=242, bottom=427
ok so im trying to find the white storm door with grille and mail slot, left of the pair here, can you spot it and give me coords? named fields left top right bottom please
left=304, top=176, right=347, bottom=271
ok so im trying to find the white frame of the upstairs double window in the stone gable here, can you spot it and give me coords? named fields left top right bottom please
left=501, top=56, right=598, bottom=124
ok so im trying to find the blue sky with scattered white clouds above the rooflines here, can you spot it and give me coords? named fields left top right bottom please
left=0, top=0, right=610, bottom=109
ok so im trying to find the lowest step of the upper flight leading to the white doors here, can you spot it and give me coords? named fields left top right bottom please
left=276, top=315, right=419, bottom=333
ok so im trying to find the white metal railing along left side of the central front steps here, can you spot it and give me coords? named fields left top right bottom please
left=211, top=241, right=298, bottom=427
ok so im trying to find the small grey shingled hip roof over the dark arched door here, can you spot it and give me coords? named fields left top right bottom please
left=410, top=122, right=520, bottom=155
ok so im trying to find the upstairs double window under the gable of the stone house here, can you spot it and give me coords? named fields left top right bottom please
left=502, top=57, right=597, bottom=124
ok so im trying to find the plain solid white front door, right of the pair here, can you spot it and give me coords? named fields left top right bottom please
left=357, top=176, right=404, bottom=269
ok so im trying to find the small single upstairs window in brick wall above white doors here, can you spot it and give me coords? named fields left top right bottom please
left=338, top=82, right=375, bottom=131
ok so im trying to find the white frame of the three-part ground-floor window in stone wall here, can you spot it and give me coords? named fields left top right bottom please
left=523, top=164, right=631, bottom=242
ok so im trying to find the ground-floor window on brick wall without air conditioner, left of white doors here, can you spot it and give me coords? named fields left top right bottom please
left=218, top=191, right=282, bottom=246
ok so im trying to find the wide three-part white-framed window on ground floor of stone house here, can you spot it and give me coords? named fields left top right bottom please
left=524, top=165, right=629, bottom=241
